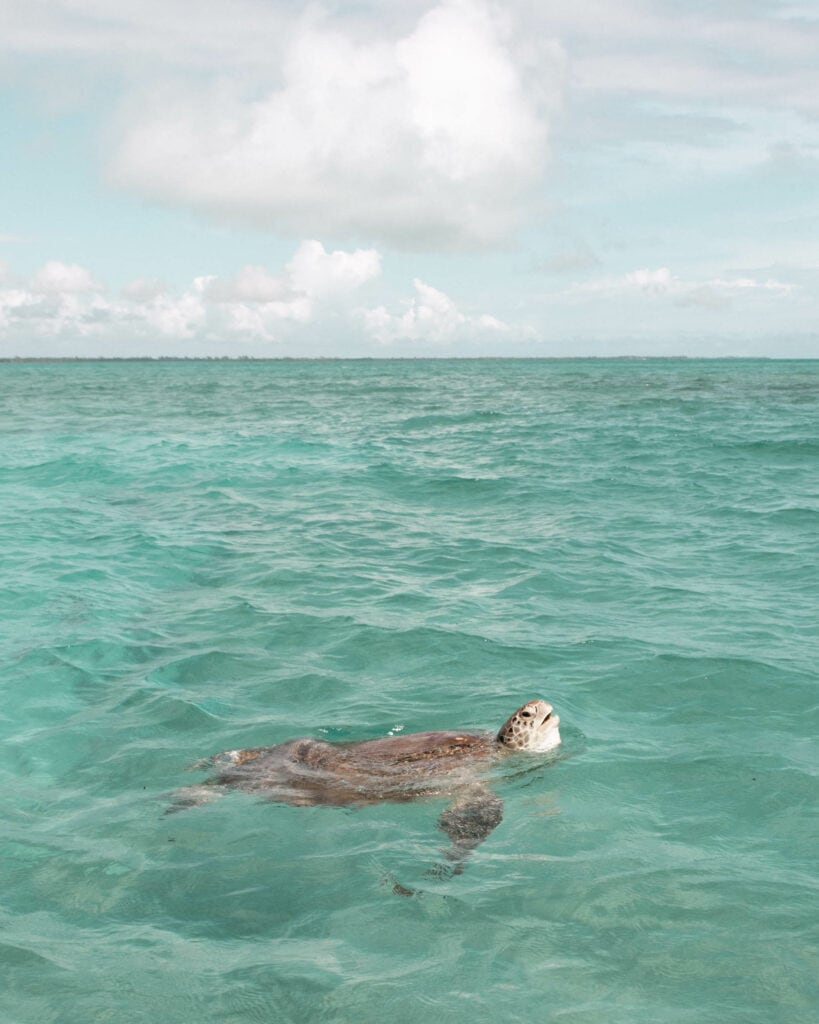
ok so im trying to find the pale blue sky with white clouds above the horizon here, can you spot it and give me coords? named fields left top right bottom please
left=0, top=0, right=819, bottom=357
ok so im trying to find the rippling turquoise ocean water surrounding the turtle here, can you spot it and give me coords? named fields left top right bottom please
left=0, top=360, right=819, bottom=1024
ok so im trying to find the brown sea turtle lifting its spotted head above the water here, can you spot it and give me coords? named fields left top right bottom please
left=169, top=700, right=560, bottom=891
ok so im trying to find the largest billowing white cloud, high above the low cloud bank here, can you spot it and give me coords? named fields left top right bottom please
left=112, top=0, right=562, bottom=247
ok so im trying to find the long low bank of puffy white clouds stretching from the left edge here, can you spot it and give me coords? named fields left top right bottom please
left=0, top=240, right=499, bottom=354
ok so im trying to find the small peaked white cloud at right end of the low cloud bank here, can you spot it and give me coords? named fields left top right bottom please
left=361, top=279, right=510, bottom=344
